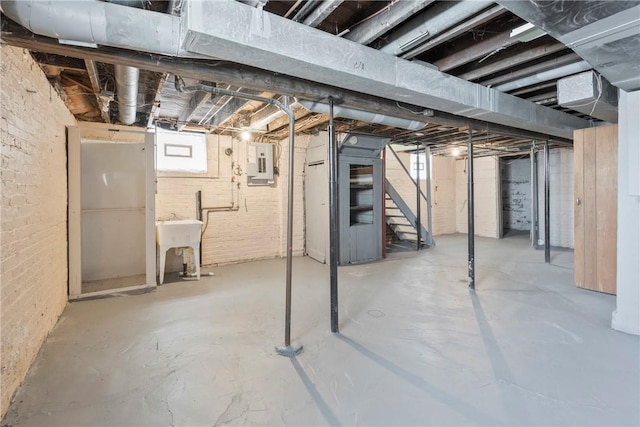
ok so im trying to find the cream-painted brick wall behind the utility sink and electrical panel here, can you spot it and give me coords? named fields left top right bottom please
left=156, top=135, right=308, bottom=271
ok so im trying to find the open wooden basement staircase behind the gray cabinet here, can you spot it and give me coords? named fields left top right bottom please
left=384, top=179, right=429, bottom=247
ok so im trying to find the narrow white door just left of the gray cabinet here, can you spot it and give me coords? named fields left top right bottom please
left=304, top=162, right=329, bottom=263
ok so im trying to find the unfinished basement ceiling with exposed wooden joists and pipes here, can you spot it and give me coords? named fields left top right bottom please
left=2, top=0, right=639, bottom=155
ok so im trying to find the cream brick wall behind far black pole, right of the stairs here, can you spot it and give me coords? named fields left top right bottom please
left=456, top=157, right=500, bottom=238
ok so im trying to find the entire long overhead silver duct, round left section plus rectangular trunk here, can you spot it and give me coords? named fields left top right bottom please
left=0, top=0, right=589, bottom=139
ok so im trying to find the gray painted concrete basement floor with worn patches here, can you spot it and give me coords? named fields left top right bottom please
left=4, top=235, right=640, bottom=426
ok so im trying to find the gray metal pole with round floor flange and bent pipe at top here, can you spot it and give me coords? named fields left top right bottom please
left=175, top=76, right=302, bottom=357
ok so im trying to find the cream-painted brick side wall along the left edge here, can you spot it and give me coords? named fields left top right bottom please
left=0, top=45, right=75, bottom=416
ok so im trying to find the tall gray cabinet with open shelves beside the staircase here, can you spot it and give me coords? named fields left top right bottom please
left=338, top=133, right=389, bottom=265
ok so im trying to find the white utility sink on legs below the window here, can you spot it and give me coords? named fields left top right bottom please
left=156, top=219, right=202, bottom=285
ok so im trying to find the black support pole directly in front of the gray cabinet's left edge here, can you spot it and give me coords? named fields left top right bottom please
left=329, top=97, right=340, bottom=334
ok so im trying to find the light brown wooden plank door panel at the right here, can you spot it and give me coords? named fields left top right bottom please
left=573, top=125, right=618, bottom=294
